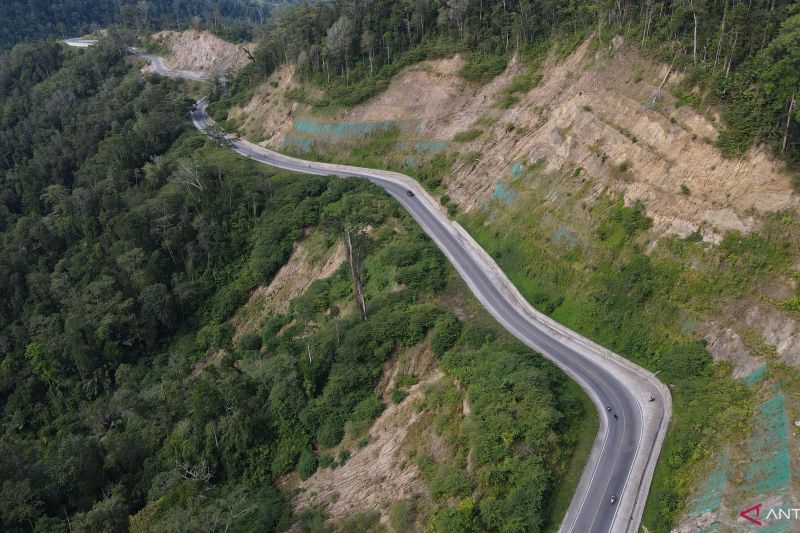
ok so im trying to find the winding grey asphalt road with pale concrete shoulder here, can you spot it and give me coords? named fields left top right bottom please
left=67, top=37, right=672, bottom=533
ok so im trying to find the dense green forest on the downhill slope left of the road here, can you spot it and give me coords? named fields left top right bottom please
left=0, top=33, right=591, bottom=532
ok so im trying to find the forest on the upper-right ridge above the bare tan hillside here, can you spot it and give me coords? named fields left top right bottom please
left=209, top=0, right=800, bottom=163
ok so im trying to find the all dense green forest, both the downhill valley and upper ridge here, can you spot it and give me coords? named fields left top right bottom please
left=0, top=0, right=800, bottom=531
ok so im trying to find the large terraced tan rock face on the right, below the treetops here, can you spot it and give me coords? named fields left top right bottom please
left=440, top=41, right=798, bottom=242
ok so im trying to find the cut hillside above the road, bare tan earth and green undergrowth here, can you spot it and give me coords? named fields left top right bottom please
left=214, top=32, right=800, bottom=530
